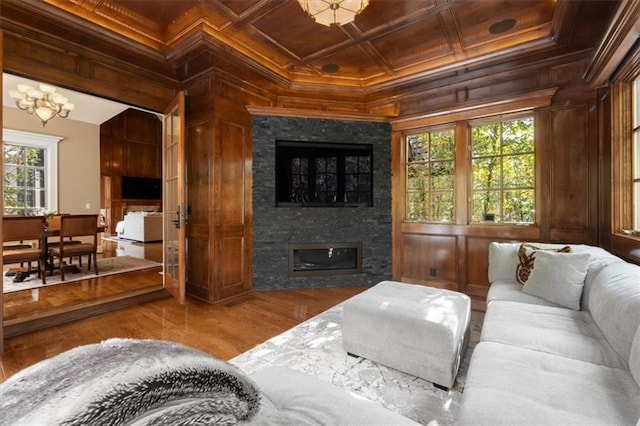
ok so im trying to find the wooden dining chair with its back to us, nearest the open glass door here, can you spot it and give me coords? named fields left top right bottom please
left=49, top=214, right=98, bottom=281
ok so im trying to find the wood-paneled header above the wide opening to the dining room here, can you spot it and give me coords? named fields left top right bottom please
left=2, top=8, right=180, bottom=111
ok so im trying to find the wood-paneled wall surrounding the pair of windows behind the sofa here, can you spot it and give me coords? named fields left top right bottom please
left=392, top=58, right=599, bottom=309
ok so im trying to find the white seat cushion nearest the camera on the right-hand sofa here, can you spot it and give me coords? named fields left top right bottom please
left=457, top=342, right=640, bottom=426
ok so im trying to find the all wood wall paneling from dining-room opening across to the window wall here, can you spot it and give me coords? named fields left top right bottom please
left=3, top=3, right=638, bottom=309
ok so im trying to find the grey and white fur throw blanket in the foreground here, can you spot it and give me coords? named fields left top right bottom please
left=0, top=339, right=260, bottom=426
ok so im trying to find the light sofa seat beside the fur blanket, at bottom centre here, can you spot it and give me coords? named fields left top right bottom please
left=251, top=367, right=418, bottom=425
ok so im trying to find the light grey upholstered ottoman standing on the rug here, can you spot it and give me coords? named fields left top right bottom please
left=343, top=281, right=471, bottom=389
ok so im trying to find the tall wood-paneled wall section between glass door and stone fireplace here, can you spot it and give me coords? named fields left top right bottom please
left=179, top=75, right=252, bottom=302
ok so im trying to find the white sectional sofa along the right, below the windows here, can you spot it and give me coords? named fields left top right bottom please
left=459, top=243, right=640, bottom=425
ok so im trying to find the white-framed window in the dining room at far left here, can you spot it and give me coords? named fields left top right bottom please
left=3, top=129, right=61, bottom=215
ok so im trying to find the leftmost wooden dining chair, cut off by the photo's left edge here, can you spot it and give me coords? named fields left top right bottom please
left=2, top=216, right=46, bottom=284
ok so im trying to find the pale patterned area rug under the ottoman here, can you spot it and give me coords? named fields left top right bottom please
left=230, top=304, right=482, bottom=426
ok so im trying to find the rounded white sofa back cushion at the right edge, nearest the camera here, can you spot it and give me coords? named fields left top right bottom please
left=589, top=262, right=640, bottom=360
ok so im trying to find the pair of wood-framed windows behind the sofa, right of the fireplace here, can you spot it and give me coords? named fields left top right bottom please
left=405, top=113, right=535, bottom=224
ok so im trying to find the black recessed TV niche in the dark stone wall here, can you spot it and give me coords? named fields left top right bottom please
left=276, top=141, right=373, bottom=207
